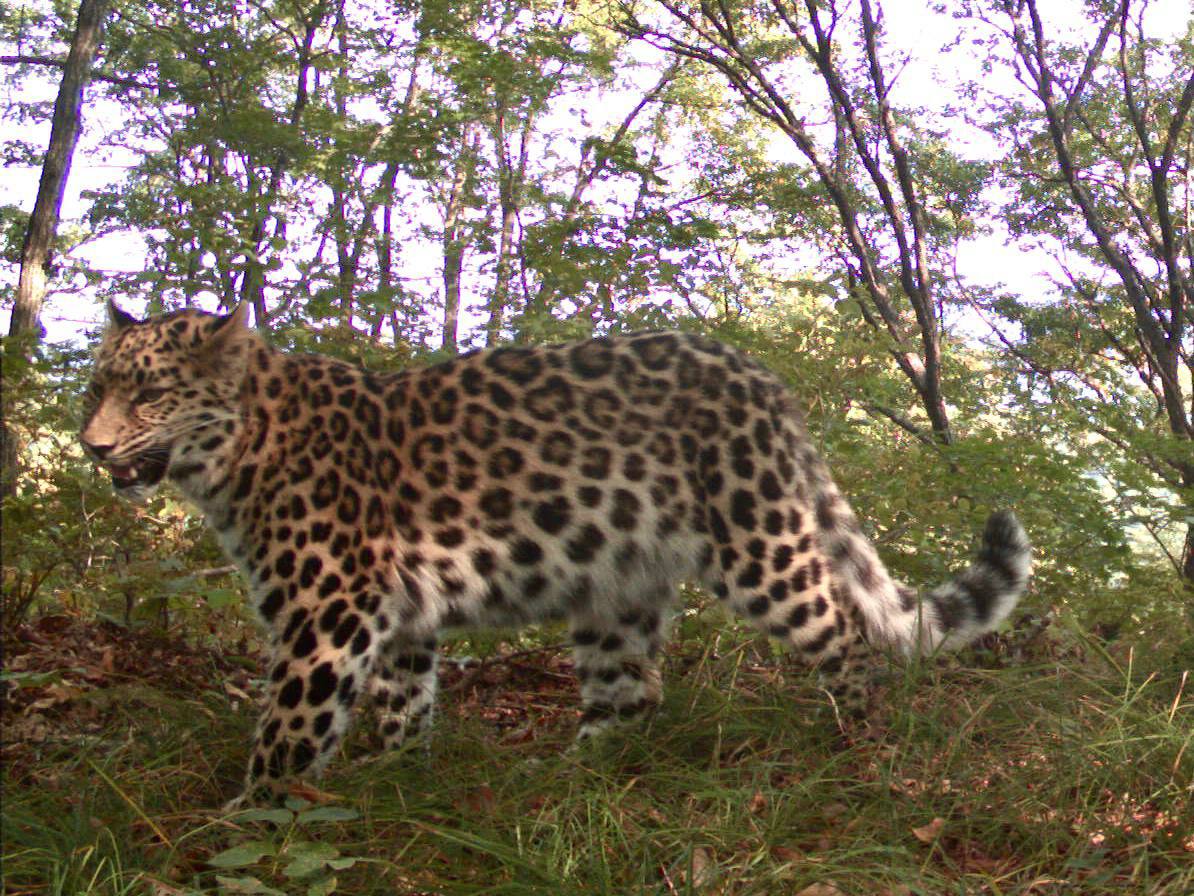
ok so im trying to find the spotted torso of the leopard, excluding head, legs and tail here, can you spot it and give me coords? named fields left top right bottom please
left=219, top=333, right=826, bottom=628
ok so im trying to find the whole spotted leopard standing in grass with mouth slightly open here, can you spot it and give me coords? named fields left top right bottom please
left=80, top=302, right=1030, bottom=808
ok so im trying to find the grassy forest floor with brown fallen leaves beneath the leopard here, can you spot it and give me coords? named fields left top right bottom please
left=0, top=612, right=1194, bottom=896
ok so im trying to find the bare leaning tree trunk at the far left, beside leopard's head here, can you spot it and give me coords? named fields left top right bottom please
left=0, top=0, right=107, bottom=496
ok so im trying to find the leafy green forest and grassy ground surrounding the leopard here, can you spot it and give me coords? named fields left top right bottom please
left=0, top=0, right=1194, bottom=896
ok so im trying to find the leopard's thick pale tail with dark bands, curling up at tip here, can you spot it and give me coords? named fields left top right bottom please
left=817, top=477, right=1032, bottom=655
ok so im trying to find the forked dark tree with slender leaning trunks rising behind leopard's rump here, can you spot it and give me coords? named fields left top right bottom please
left=622, top=0, right=954, bottom=444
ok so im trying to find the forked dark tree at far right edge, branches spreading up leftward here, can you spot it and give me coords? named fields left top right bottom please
left=1001, top=0, right=1194, bottom=595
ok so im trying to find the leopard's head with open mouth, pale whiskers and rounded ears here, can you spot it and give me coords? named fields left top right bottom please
left=80, top=302, right=256, bottom=501
